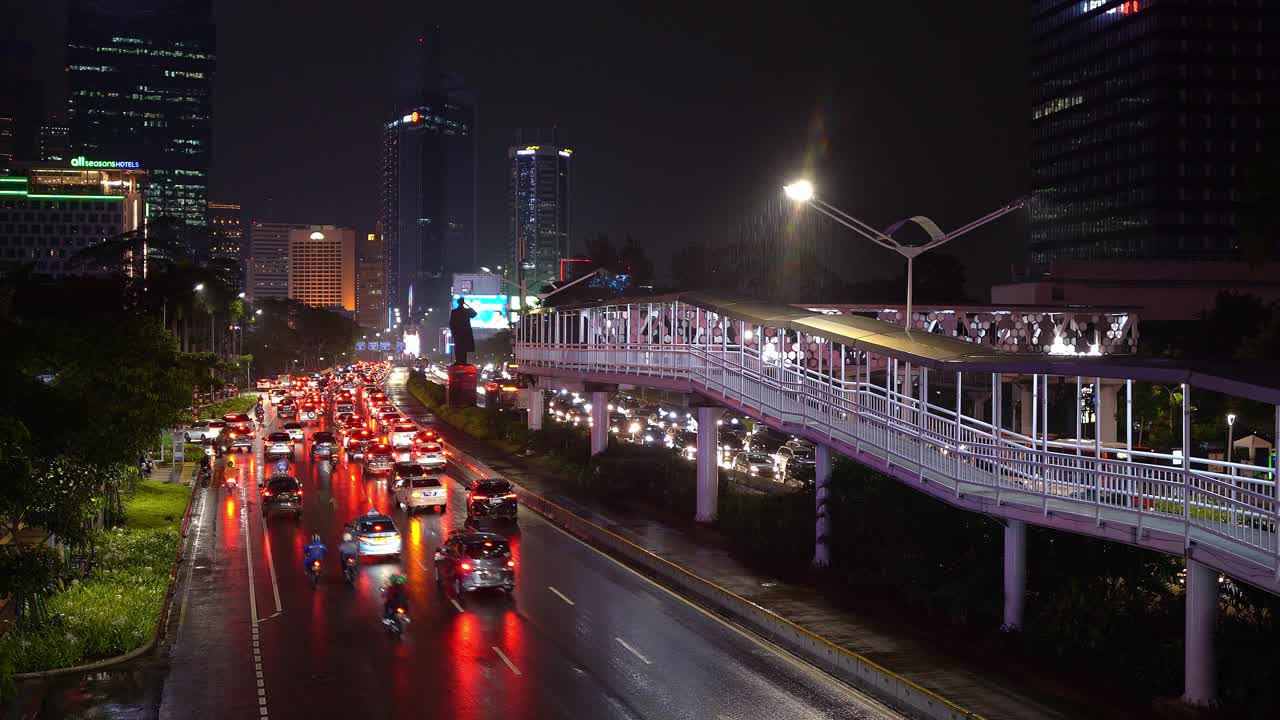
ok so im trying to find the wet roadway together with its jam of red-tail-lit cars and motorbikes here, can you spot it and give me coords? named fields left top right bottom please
left=160, top=364, right=899, bottom=719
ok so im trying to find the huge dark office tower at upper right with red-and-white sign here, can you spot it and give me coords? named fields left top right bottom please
left=1030, top=0, right=1280, bottom=266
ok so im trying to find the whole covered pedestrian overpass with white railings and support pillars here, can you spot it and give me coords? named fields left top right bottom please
left=512, top=293, right=1280, bottom=703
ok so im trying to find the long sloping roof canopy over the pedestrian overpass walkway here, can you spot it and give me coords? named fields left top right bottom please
left=532, top=292, right=1280, bottom=405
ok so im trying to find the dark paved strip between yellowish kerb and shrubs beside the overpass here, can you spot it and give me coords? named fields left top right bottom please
left=437, top=432, right=1149, bottom=720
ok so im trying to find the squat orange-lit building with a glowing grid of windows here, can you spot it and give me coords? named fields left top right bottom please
left=289, top=225, right=356, bottom=314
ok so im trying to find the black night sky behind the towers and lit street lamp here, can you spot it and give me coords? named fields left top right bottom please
left=5, top=0, right=1029, bottom=299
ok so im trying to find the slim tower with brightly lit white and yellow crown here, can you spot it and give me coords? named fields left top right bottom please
left=507, top=135, right=572, bottom=293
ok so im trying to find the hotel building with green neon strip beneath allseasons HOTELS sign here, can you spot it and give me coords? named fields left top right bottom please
left=0, top=164, right=145, bottom=277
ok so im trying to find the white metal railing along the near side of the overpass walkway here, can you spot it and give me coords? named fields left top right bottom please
left=515, top=340, right=1280, bottom=573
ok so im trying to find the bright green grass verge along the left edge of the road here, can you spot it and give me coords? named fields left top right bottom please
left=0, top=480, right=191, bottom=673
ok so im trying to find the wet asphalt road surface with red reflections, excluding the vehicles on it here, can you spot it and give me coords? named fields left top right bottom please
left=142, top=370, right=895, bottom=719
